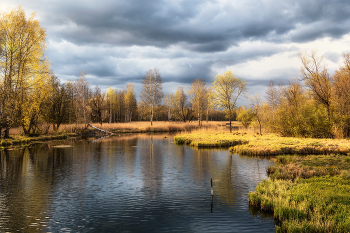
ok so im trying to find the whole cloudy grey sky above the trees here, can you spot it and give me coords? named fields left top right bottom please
left=0, top=0, right=350, bottom=103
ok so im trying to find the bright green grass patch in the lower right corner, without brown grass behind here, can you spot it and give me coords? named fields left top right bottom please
left=249, top=176, right=350, bottom=232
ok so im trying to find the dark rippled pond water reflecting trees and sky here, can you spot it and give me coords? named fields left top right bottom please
left=0, top=135, right=275, bottom=232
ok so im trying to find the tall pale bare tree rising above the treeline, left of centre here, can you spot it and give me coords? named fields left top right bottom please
left=140, top=68, right=164, bottom=125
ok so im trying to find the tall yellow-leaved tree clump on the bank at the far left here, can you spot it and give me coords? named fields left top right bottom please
left=0, top=6, right=49, bottom=137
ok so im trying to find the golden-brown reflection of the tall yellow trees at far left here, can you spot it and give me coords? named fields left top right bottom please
left=0, top=146, right=72, bottom=232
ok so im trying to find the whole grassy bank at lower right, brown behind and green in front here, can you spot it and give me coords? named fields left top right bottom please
left=249, top=155, right=350, bottom=232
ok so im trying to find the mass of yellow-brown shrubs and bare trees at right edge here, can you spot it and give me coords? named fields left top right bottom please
left=237, top=51, right=350, bottom=138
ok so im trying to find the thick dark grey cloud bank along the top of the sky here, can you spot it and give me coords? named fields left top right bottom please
left=30, top=0, right=350, bottom=52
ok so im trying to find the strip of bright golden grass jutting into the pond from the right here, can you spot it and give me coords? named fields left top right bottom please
left=175, top=132, right=350, bottom=156
